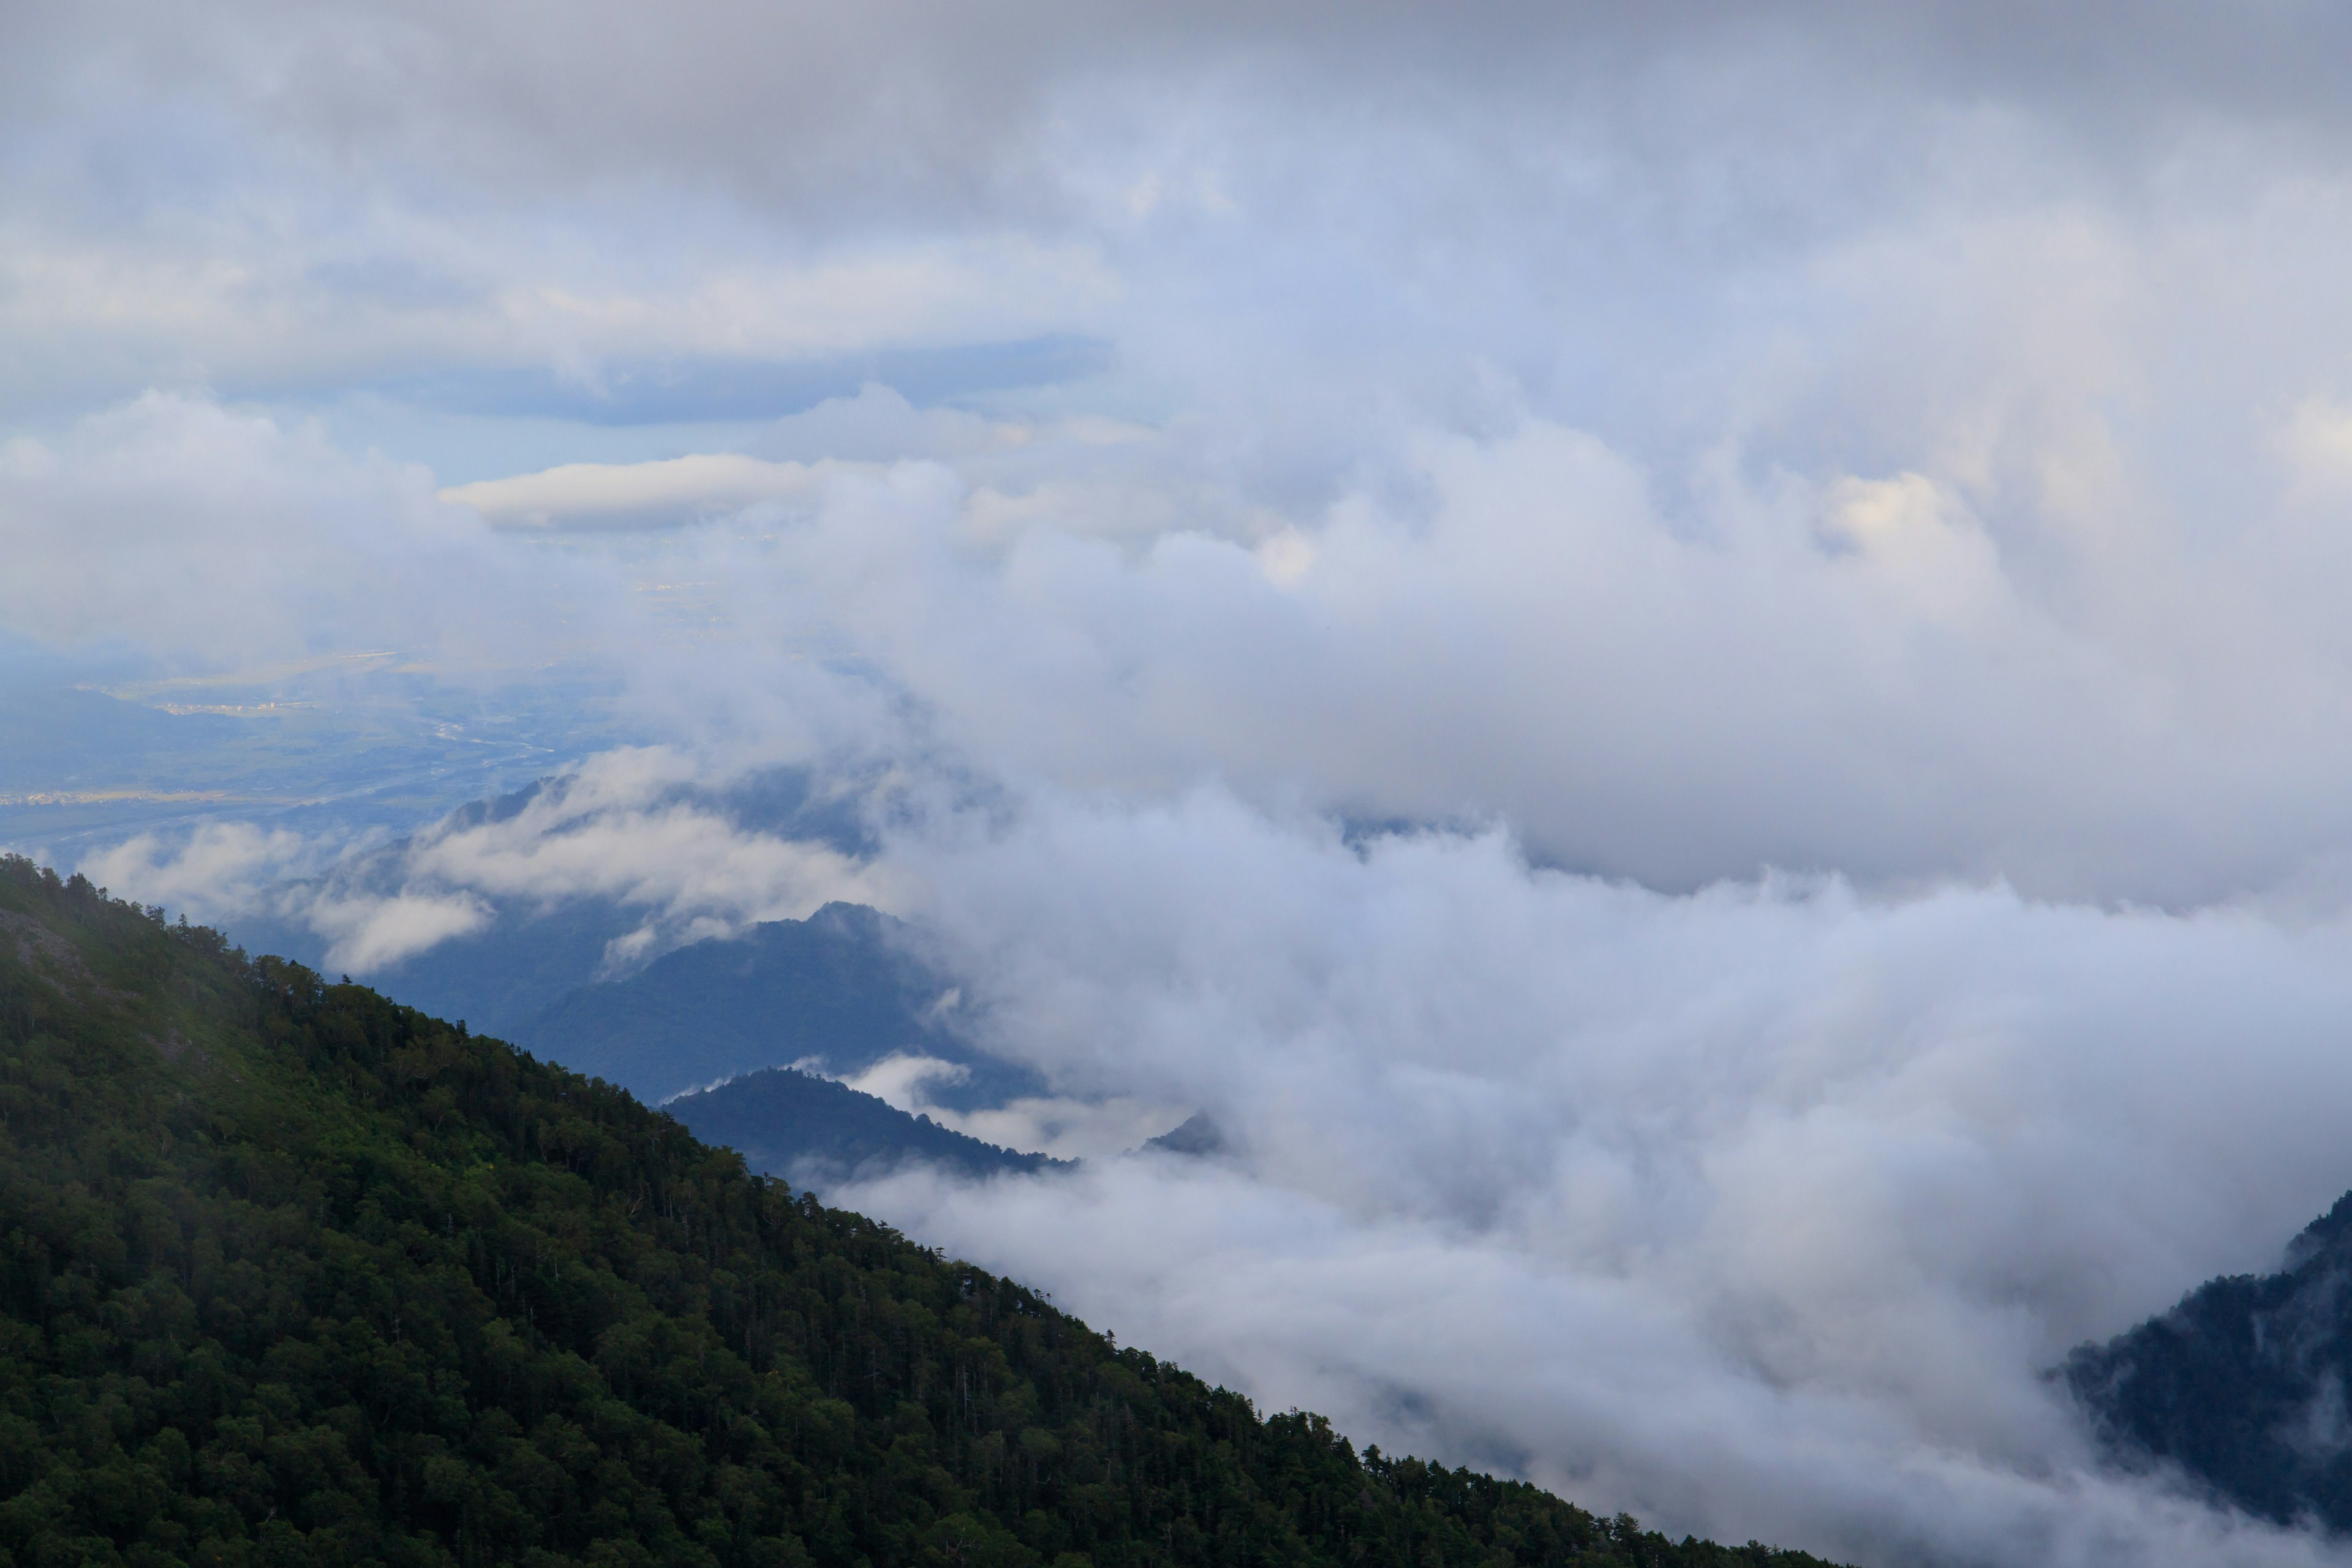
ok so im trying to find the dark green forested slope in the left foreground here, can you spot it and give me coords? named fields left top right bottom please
left=0, top=858, right=1844, bottom=1568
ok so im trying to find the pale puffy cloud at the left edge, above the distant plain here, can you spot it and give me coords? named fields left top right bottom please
left=0, top=393, right=625, bottom=670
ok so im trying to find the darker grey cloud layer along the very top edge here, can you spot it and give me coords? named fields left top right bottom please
left=17, top=0, right=2345, bottom=211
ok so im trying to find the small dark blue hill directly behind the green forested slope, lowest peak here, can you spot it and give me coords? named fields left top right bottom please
left=663, top=1067, right=1077, bottom=1187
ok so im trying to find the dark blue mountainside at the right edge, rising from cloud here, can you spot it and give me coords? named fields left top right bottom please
left=2060, top=1194, right=2352, bottom=1531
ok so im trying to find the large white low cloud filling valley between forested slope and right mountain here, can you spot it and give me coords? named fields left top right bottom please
left=845, top=792, right=2352, bottom=1563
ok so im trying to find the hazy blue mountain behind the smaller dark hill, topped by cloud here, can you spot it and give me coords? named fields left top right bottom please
left=513, top=903, right=1035, bottom=1105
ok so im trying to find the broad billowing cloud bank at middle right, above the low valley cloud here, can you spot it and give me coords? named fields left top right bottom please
left=538, top=390, right=2352, bottom=903
